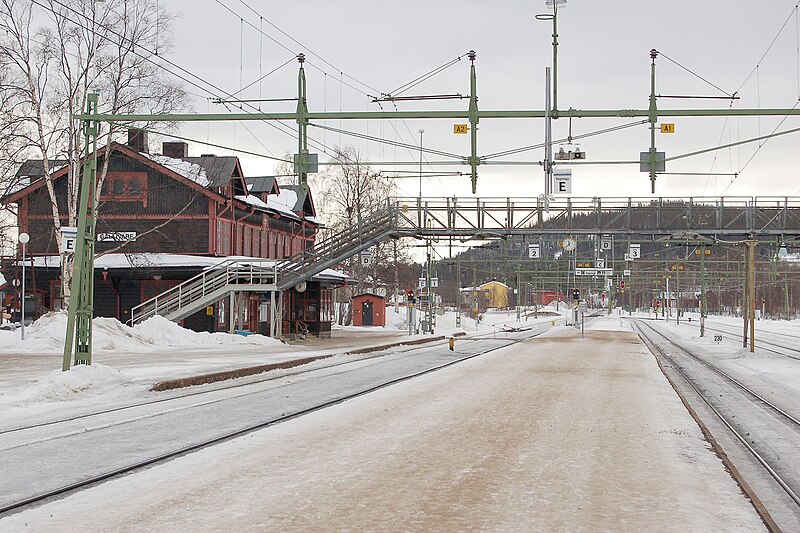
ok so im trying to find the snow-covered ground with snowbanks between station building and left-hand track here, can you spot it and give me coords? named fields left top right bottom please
left=0, top=306, right=563, bottom=426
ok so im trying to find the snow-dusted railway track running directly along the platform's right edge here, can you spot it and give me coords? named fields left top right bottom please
left=633, top=320, right=800, bottom=530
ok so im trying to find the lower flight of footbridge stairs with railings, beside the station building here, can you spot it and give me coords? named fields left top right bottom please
left=130, top=259, right=278, bottom=325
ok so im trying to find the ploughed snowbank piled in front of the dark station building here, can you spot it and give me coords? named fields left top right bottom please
left=0, top=312, right=281, bottom=353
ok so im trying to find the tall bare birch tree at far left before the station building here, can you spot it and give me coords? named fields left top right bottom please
left=0, top=0, right=186, bottom=301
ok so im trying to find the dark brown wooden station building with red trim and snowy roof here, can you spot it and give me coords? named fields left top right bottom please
left=0, top=130, right=344, bottom=333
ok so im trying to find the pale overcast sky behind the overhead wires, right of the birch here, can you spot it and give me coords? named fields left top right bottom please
left=164, top=0, right=800, bottom=197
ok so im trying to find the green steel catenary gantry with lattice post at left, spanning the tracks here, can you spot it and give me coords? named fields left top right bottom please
left=63, top=52, right=800, bottom=370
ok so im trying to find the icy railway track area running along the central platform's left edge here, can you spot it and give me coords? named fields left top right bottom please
left=0, top=326, right=547, bottom=517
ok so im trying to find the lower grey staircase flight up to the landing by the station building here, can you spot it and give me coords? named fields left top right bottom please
left=130, top=259, right=278, bottom=325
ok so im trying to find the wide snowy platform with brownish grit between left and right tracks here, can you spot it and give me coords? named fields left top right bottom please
left=0, top=319, right=764, bottom=532
